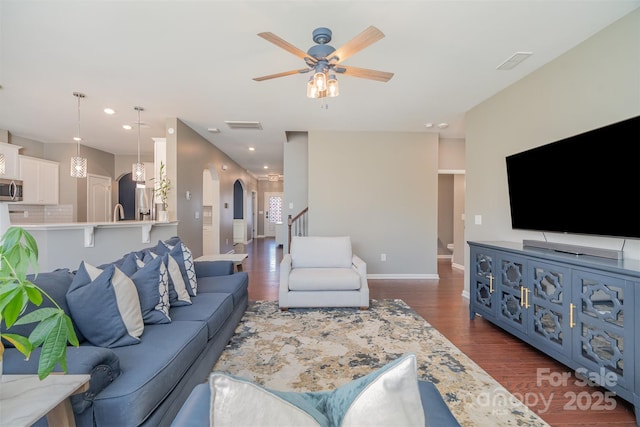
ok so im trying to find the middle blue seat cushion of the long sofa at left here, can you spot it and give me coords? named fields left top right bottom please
left=170, top=292, right=233, bottom=339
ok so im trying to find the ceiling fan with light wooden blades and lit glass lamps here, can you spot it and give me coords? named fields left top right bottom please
left=253, top=26, right=393, bottom=98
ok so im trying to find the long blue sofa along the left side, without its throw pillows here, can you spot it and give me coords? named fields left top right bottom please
left=4, top=238, right=249, bottom=427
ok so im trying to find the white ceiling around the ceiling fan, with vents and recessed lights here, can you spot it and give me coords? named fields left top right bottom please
left=0, top=0, right=640, bottom=176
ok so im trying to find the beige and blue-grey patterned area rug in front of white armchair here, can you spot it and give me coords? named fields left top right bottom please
left=214, top=300, right=547, bottom=427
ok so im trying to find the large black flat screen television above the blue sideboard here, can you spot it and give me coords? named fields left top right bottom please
left=506, top=116, right=640, bottom=239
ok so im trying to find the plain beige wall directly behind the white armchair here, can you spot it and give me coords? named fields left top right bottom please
left=308, top=132, right=438, bottom=278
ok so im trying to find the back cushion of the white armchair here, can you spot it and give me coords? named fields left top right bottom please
left=290, top=236, right=353, bottom=268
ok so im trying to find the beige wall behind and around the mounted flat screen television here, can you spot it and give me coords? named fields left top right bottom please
left=465, top=10, right=640, bottom=296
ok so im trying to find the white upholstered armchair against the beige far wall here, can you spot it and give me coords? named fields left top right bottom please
left=278, top=236, right=369, bottom=311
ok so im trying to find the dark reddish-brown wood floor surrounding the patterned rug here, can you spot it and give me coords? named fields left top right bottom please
left=243, top=238, right=636, bottom=427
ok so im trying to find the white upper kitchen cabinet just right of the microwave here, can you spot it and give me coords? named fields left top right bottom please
left=20, top=156, right=60, bottom=205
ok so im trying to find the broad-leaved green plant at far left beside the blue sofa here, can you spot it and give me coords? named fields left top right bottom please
left=0, top=227, right=78, bottom=380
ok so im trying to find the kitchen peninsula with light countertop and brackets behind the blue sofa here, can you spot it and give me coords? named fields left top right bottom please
left=16, top=221, right=178, bottom=272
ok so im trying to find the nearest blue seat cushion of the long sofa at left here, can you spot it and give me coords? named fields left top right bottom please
left=93, top=320, right=208, bottom=427
